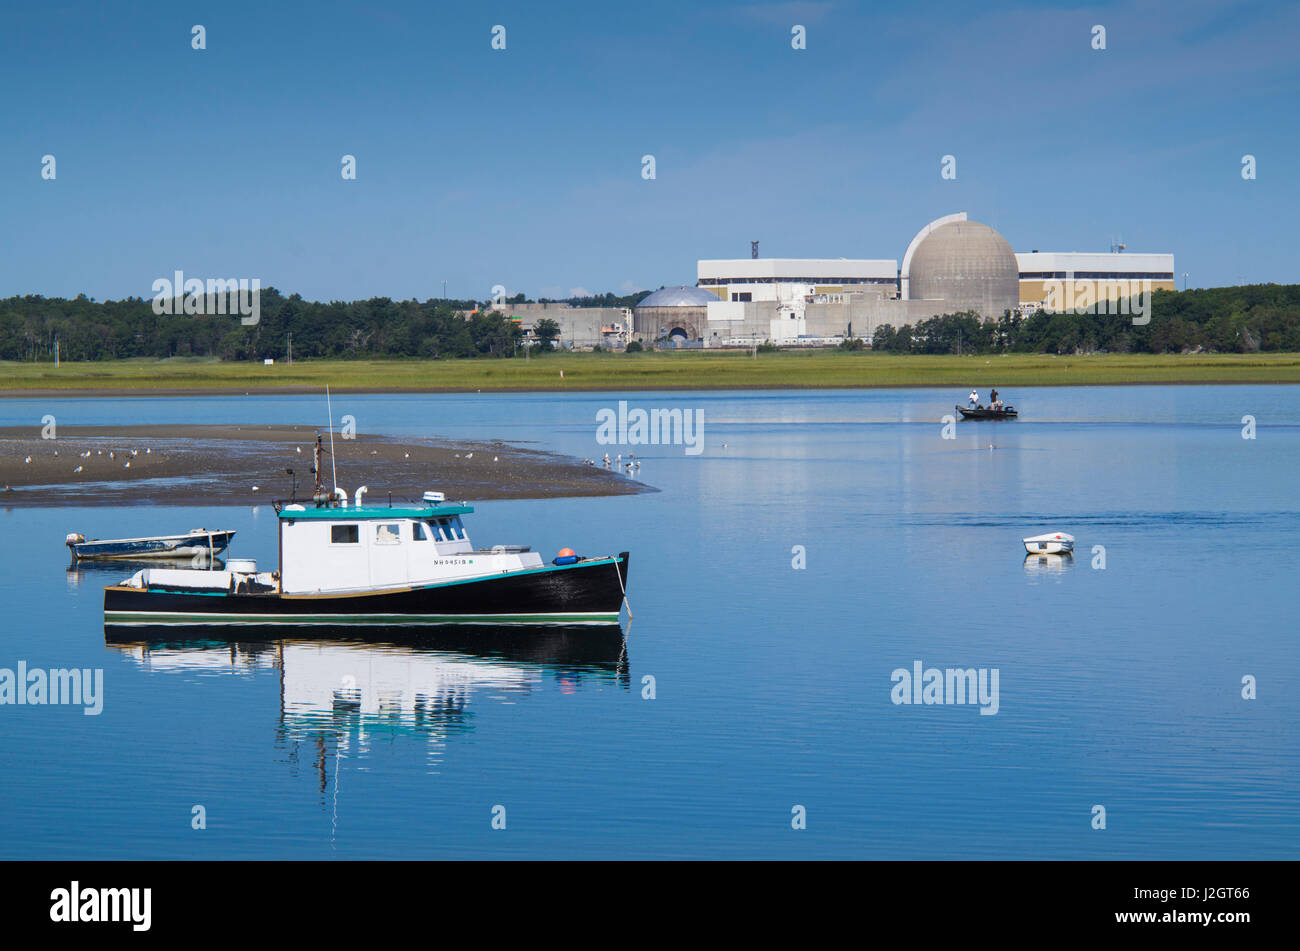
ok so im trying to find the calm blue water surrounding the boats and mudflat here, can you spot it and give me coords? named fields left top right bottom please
left=0, top=386, right=1300, bottom=859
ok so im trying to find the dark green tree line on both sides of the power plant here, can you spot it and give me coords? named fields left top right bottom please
left=0, top=285, right=1300, bottom=361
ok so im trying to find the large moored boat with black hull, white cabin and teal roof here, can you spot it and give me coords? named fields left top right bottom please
left=104, top=437, right=629, bottom=626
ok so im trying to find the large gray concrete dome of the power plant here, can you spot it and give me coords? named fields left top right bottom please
left=907, top=221, right=1021, bottom=317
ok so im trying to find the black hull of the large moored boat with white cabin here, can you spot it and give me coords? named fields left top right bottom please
left=104, top=552, right=628, bottom=626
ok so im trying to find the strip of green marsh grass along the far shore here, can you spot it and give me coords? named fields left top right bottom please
left=0, top=349, right=1300, bottom=400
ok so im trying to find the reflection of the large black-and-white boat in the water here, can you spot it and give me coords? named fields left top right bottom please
left=104, top=625, right=629, bottom=790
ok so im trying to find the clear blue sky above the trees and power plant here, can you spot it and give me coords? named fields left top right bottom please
left=0, top=0, right=1300, bottom=300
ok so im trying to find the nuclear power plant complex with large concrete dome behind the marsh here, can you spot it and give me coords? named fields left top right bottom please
left=498, top=212, right=1174, bottom=349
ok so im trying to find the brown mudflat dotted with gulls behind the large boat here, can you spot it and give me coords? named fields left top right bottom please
left=0, top=424, right=658, bottom=507
